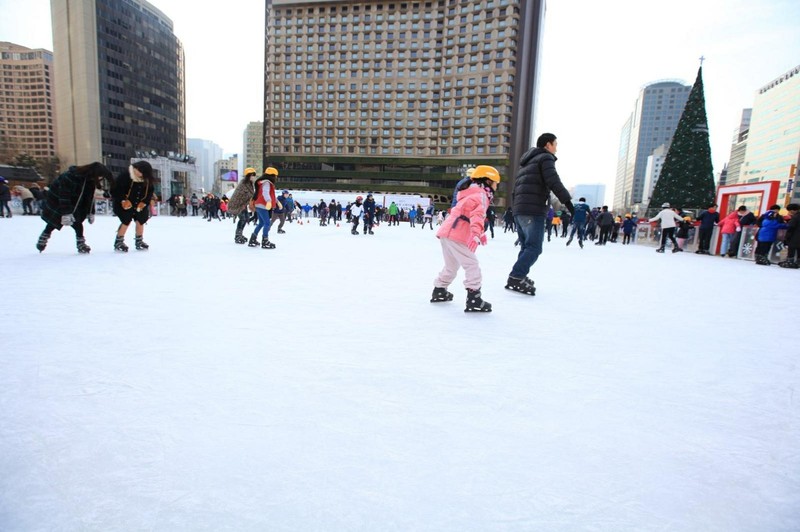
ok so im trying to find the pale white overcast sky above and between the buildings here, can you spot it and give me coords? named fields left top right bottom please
left=0, top=0, right=800, bottom=203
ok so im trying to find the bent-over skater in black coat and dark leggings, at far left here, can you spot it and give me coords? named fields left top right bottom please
left=36, top=162, right=113, bottom=253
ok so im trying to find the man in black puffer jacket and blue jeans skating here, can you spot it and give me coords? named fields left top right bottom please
left=506, top=133, right=575, bottom=296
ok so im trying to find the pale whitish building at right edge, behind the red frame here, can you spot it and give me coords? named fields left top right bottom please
left=738, top=62, right=800, bottom=204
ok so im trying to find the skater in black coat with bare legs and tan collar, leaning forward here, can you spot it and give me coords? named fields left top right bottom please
left=111, top=161, right=155, bottom=252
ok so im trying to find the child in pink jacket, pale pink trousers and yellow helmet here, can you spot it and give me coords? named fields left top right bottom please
left=431, top=165, right=500, bottom=312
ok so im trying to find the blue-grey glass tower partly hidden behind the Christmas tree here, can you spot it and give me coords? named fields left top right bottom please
left=613, top=81, right=692, bottom=212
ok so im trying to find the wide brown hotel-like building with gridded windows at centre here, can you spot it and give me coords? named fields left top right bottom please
left=264, top=0, right=544, bottom=205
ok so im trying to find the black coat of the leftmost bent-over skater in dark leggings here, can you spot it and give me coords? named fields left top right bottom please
left=42, top=166, right=95, bottom=230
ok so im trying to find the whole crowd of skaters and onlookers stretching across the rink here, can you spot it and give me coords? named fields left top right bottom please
left=12, top=133, right=800, bottom=312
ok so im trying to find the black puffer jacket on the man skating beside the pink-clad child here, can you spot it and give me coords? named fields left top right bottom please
left=512, top=148, right=572, bottom=216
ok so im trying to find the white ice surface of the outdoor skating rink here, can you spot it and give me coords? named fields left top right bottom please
left=0, top=216, right=800, bottom=531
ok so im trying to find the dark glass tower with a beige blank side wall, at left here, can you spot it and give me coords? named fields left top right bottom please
left=50, top=0, right=186, bottom=173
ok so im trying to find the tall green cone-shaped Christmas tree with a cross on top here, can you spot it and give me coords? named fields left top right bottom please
left=648, top=66, right=715, bottom=213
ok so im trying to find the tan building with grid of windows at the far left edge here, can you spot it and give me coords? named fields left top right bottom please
left=0, top=42, right=57, bottom=161
